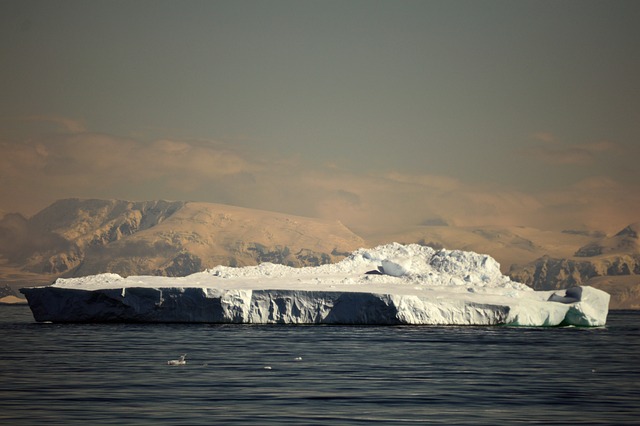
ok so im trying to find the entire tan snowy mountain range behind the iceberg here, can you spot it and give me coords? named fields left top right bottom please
left=0, top=199, right=640, bottom=309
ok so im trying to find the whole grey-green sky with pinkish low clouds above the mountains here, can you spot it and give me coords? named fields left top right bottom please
left=0, top=0, right=640, bottom=234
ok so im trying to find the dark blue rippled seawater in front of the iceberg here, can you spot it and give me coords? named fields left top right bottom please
left=0, top=306, right=640, bottom=425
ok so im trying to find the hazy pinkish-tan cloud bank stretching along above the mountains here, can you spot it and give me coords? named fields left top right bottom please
left=0, top=123, right=640, bottom=236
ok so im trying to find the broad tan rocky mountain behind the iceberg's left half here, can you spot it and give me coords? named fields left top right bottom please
left=0, top=199, right=364, bottom=290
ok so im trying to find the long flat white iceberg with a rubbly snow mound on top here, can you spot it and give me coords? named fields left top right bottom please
left=20, top=243, right=610, bottom=327
